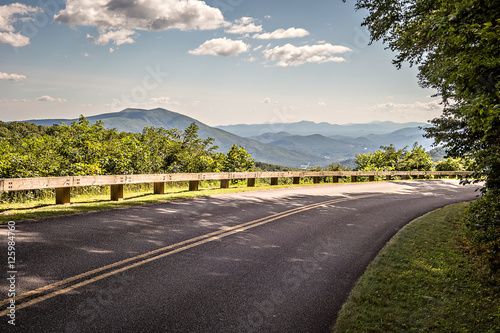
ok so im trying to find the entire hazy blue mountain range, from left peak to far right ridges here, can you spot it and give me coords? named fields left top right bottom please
left=17, top=108, right=432, bottom=167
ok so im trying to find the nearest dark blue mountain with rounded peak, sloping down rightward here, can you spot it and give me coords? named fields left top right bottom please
left=19, top=108, right=329, bottom=167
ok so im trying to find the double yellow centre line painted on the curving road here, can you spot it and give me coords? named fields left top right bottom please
left=0, top=193, right=387, bottom=317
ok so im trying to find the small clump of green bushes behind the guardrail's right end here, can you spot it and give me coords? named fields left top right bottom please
left=354, top=142, right=433, bottom=171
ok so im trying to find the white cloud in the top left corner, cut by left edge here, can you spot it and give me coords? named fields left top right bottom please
left=0, top=3, right=41, bottom=47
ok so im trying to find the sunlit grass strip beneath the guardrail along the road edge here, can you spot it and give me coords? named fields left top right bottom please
left=0, top=180, right=340, bottom=224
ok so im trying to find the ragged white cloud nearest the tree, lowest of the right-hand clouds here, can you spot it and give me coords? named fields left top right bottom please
left=262, top=44, right=352, bottom=67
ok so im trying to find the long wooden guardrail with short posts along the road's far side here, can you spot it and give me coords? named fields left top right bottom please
left=0, top=171, right=472, bottom=204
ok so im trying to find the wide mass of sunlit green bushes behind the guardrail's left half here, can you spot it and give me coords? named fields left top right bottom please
left=0, top=116, right=253, bottom=197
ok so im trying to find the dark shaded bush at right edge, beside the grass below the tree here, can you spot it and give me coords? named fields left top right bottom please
left=464, top=191, right=500, bottom=269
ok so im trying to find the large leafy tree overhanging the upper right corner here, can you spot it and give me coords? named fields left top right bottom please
left=356, top=0, right=500, bottom=194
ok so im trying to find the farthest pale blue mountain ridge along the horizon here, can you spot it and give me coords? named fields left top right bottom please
left=216, top=121, right=429, bottom=138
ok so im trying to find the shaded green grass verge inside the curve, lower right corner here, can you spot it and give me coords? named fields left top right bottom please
left=333, top=203, right=500, bottom=333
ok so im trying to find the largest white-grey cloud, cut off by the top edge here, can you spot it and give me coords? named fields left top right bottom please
left=54, top=0, right=224, bottom=31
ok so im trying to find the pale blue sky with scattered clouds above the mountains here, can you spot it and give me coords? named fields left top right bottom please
left=0, top=0, right=442, bottom=126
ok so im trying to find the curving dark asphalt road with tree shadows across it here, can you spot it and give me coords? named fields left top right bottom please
left=0, top=180, right=478, bottom=333
